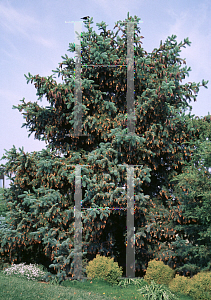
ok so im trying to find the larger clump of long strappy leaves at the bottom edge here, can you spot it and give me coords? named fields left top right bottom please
left=138, top=280, right=179, bottom=300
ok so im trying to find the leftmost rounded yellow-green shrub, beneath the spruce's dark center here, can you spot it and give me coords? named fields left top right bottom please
left=86, top=254, right=123, bottom=284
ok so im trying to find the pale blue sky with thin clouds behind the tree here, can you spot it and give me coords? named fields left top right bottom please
left=0, top=0, right=211, bottom=187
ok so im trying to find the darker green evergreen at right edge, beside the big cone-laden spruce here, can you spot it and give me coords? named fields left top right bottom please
left=171, top=116, right=211, bottom=277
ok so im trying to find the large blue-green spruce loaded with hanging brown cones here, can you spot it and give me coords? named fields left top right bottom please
left=1, top=13, right=207, bottom=280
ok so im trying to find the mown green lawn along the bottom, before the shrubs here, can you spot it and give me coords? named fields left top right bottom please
left=0, top=271, right=195, bottom=300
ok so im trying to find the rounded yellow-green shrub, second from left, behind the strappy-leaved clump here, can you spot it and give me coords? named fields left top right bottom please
left=144, top=259, right=175, bottom=286
